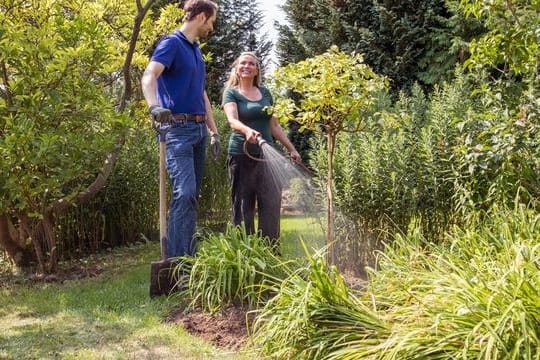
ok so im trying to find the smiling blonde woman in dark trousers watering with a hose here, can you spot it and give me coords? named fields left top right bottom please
left=222, top=52, right=302, bottom=245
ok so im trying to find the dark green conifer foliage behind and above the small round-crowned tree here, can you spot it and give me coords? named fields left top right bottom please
left=277, top=0, right=470, bottom=91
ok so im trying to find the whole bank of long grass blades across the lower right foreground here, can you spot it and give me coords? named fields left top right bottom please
left=255, top=208, right=540, bottom=359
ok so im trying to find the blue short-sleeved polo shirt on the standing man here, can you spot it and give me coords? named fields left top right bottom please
left=151, top=30, right=206, bottom=115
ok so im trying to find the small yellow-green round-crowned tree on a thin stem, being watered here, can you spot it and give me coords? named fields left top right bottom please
left=274, top=47, right=387, bottom=264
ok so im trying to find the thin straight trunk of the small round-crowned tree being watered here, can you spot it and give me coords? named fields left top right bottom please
left=326, top=133, right=337, bottom=265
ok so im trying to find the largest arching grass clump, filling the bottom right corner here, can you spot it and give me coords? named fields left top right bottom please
left=366, top=205, right=540, bottom=359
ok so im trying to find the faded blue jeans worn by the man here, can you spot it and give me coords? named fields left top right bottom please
left=167, top=121, right=206, bottom=258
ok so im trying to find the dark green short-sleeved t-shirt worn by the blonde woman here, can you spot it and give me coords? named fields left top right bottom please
left=221, top=86, right=274, bottom=155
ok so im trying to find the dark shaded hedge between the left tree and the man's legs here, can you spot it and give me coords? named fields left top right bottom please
left=57, top=126, right=159, bottom=258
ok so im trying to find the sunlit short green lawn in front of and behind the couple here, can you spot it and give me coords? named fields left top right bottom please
left=0, top=217, right=323, bottom=359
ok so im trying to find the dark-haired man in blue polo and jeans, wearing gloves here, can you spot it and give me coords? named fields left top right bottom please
left=141, top=0, right=220, bottom=258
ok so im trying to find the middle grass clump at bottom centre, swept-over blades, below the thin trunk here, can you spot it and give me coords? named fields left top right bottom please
left=253, top=246, right=389, bottom=359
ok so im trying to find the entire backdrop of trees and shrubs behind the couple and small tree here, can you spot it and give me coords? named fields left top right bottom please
left=0, top=0, right=540, bottom=272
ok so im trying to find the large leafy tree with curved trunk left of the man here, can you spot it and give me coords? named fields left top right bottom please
left=0, top=0, right=181, bottom=273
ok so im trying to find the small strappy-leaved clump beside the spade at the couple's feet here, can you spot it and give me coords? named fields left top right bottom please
left=180, top=226, right=296, bottom=312
